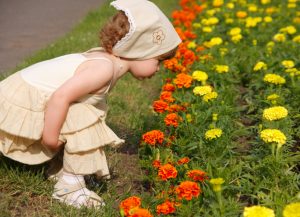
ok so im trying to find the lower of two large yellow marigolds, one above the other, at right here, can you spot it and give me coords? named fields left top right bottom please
left=260, top=129, right=286, bottom=147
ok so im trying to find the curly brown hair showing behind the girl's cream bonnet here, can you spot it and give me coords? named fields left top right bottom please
left=99, top=11, right=130, bottom=53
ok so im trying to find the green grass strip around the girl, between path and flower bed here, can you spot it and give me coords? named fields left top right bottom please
left=0, top=0, right=178, bottom=217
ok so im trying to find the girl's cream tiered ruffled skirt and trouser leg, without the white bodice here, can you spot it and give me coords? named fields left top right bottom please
left=0, top=73, right=124, bottom=175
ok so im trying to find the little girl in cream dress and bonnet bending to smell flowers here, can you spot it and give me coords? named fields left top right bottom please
left=0, top=0, right=181, bottom=207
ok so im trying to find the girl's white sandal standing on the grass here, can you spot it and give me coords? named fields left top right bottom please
left=52, top=179, right=105, bottom=208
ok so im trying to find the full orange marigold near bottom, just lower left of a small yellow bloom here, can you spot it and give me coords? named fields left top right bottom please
left=175, top=181, right=201, bottom=200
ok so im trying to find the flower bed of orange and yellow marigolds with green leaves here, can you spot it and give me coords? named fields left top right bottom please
left=120, top=0, right=300, bottom=217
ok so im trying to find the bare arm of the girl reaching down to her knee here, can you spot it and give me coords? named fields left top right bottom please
left=42, top=60, right=113, bottom=149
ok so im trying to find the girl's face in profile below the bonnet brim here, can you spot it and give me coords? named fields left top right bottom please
left=130, top=58, right=160, bottom=80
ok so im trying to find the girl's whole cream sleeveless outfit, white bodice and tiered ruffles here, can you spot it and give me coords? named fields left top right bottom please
left=0, top=49, right=124, bottom=175
